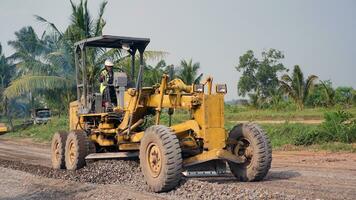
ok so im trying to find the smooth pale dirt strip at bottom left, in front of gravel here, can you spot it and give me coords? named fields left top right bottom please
left=0, top=167, right=161, bottom=200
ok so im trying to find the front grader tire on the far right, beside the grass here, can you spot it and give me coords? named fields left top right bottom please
left=228, top=123, right=272, bottom=182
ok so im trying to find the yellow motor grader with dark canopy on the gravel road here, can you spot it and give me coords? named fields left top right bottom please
left=52, top=35, right=272, bottom=192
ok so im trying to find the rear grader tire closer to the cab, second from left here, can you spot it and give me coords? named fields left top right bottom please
left=65, top=131, right=90, bottom=170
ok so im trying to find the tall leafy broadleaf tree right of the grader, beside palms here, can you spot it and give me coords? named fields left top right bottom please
left=236, top=49, right=285, bottom=103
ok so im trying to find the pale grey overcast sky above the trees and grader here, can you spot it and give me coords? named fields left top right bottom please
left=0, top=0, right=356, bottom=100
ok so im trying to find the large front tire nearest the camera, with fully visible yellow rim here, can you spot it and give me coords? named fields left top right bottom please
left=140, top=125, right=183, bottom=192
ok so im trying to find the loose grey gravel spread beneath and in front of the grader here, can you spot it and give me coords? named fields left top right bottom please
left=0, top=160, right=294, bottom=199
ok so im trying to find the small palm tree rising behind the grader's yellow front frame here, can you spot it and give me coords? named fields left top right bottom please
left=178, top=59, right=203, bottom=85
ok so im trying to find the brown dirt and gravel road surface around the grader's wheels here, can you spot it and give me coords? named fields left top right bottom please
left=0, top=138, right=356, bottom=199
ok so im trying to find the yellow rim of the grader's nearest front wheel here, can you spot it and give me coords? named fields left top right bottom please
left=146, top=143, right=162, bottom=177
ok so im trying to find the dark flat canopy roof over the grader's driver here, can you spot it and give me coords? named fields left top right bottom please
left=74, top=35, right=150, bottom=51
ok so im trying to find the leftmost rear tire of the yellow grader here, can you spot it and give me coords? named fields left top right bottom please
left=51, top=131, right=68, bottom=169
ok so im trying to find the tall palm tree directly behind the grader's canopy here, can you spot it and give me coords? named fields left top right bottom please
left=35, top=0, right=167, bottom=87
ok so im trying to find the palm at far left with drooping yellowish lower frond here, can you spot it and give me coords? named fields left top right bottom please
left=4, top=27, right=70, bottom=98
